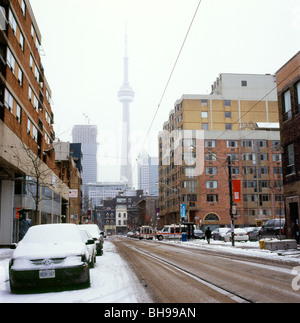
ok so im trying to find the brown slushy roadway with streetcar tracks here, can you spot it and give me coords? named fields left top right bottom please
left=114, top=237, right=300, bottom=303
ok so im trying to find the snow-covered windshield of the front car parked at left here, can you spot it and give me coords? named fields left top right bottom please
left=22, top=224, right=81, bottom=244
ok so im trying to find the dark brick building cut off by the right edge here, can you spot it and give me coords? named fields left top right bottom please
left=276, top=52, right=300, bottom=242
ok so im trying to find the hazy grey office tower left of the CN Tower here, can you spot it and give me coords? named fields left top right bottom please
left=72, top=125, right=98, bottom=184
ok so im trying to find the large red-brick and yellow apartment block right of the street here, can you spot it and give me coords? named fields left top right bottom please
left=159, top=74, right=283, bottom=230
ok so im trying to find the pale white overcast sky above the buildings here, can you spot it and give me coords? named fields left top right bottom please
left=30, top=0, right=300, bottom=186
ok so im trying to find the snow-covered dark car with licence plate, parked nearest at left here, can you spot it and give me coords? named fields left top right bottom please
left=9, top=224, right=90, bottom=292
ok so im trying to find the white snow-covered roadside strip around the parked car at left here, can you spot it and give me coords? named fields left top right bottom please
left=0, top=240, right=151, bottom=303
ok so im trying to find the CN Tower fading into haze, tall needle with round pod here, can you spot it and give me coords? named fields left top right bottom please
left=118, top=33, right=134, bottom=188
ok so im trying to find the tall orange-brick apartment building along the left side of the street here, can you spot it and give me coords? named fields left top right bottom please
left=0, top=0, right=69, bottom=245
